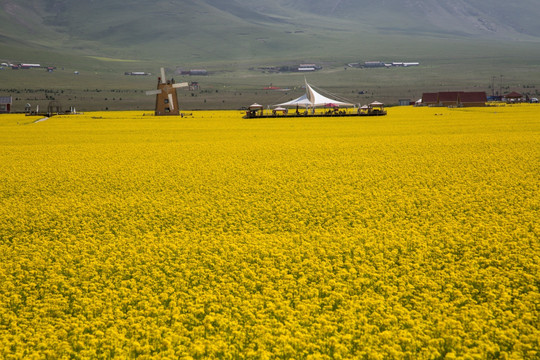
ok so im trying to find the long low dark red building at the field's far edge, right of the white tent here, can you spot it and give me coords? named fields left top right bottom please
left=417, top=91, right=488, bottom=107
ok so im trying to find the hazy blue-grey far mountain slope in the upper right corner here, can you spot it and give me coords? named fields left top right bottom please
left=244, top=0, right=540, bottom=37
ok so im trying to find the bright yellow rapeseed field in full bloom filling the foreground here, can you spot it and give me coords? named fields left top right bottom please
left=0, top=105, right=540, bottom=359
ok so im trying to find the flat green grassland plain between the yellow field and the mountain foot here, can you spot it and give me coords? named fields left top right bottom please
left=4, top=39, right=540, bottom=111
